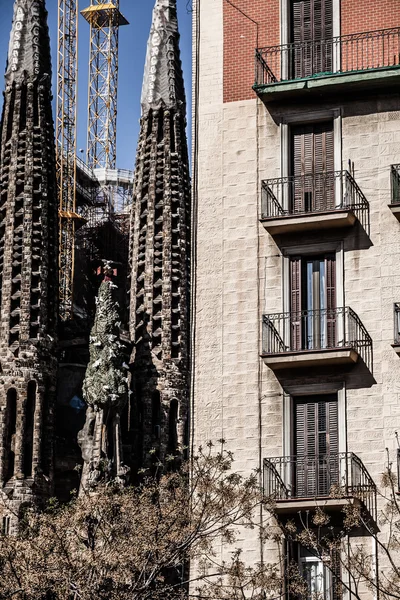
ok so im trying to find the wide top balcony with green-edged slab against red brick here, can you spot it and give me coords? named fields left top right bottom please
left=253, top=27, right=400, bottom=102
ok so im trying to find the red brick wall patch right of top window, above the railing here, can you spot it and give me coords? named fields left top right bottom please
left=341, top=0, right=400, bottom=35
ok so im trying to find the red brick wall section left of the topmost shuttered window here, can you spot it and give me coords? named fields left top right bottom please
left=220, top=0, right=280, bottom=102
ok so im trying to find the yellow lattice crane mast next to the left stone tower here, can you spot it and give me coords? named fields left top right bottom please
left=56, top=0, right=80, bottom=321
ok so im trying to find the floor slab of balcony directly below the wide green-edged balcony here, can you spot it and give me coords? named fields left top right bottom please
left=261, top=210, right=356, bottom=235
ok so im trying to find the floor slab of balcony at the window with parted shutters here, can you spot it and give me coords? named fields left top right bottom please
left=261, top=348, right=359, bottom=371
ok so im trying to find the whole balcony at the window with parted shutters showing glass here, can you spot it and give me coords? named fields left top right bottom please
left=261, top=307, right=372, bottom=373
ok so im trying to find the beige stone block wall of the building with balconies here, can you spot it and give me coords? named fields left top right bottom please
left=192, top=0, right=400, bottom=584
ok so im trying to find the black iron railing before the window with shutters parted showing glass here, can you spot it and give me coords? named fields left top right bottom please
left=262, top=306, right=373, bottom=372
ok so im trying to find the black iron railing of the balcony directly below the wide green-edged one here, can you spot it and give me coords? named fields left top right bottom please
left=261, top=171, right=369, bottom=233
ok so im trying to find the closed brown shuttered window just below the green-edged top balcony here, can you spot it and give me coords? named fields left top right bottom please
left=289, top=121, right=335, bottom=213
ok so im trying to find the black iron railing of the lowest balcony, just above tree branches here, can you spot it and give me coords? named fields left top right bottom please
left=264, top=452, right=376, bottom=521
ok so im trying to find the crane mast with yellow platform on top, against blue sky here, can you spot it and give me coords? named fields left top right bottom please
left=82, top=0, right=128, bottom=169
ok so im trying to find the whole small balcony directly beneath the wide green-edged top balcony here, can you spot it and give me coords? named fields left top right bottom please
left=260, top=171, right=369, bottom=235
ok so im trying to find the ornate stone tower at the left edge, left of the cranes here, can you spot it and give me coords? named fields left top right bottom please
left=0, top=0, right=58, bottom=528
